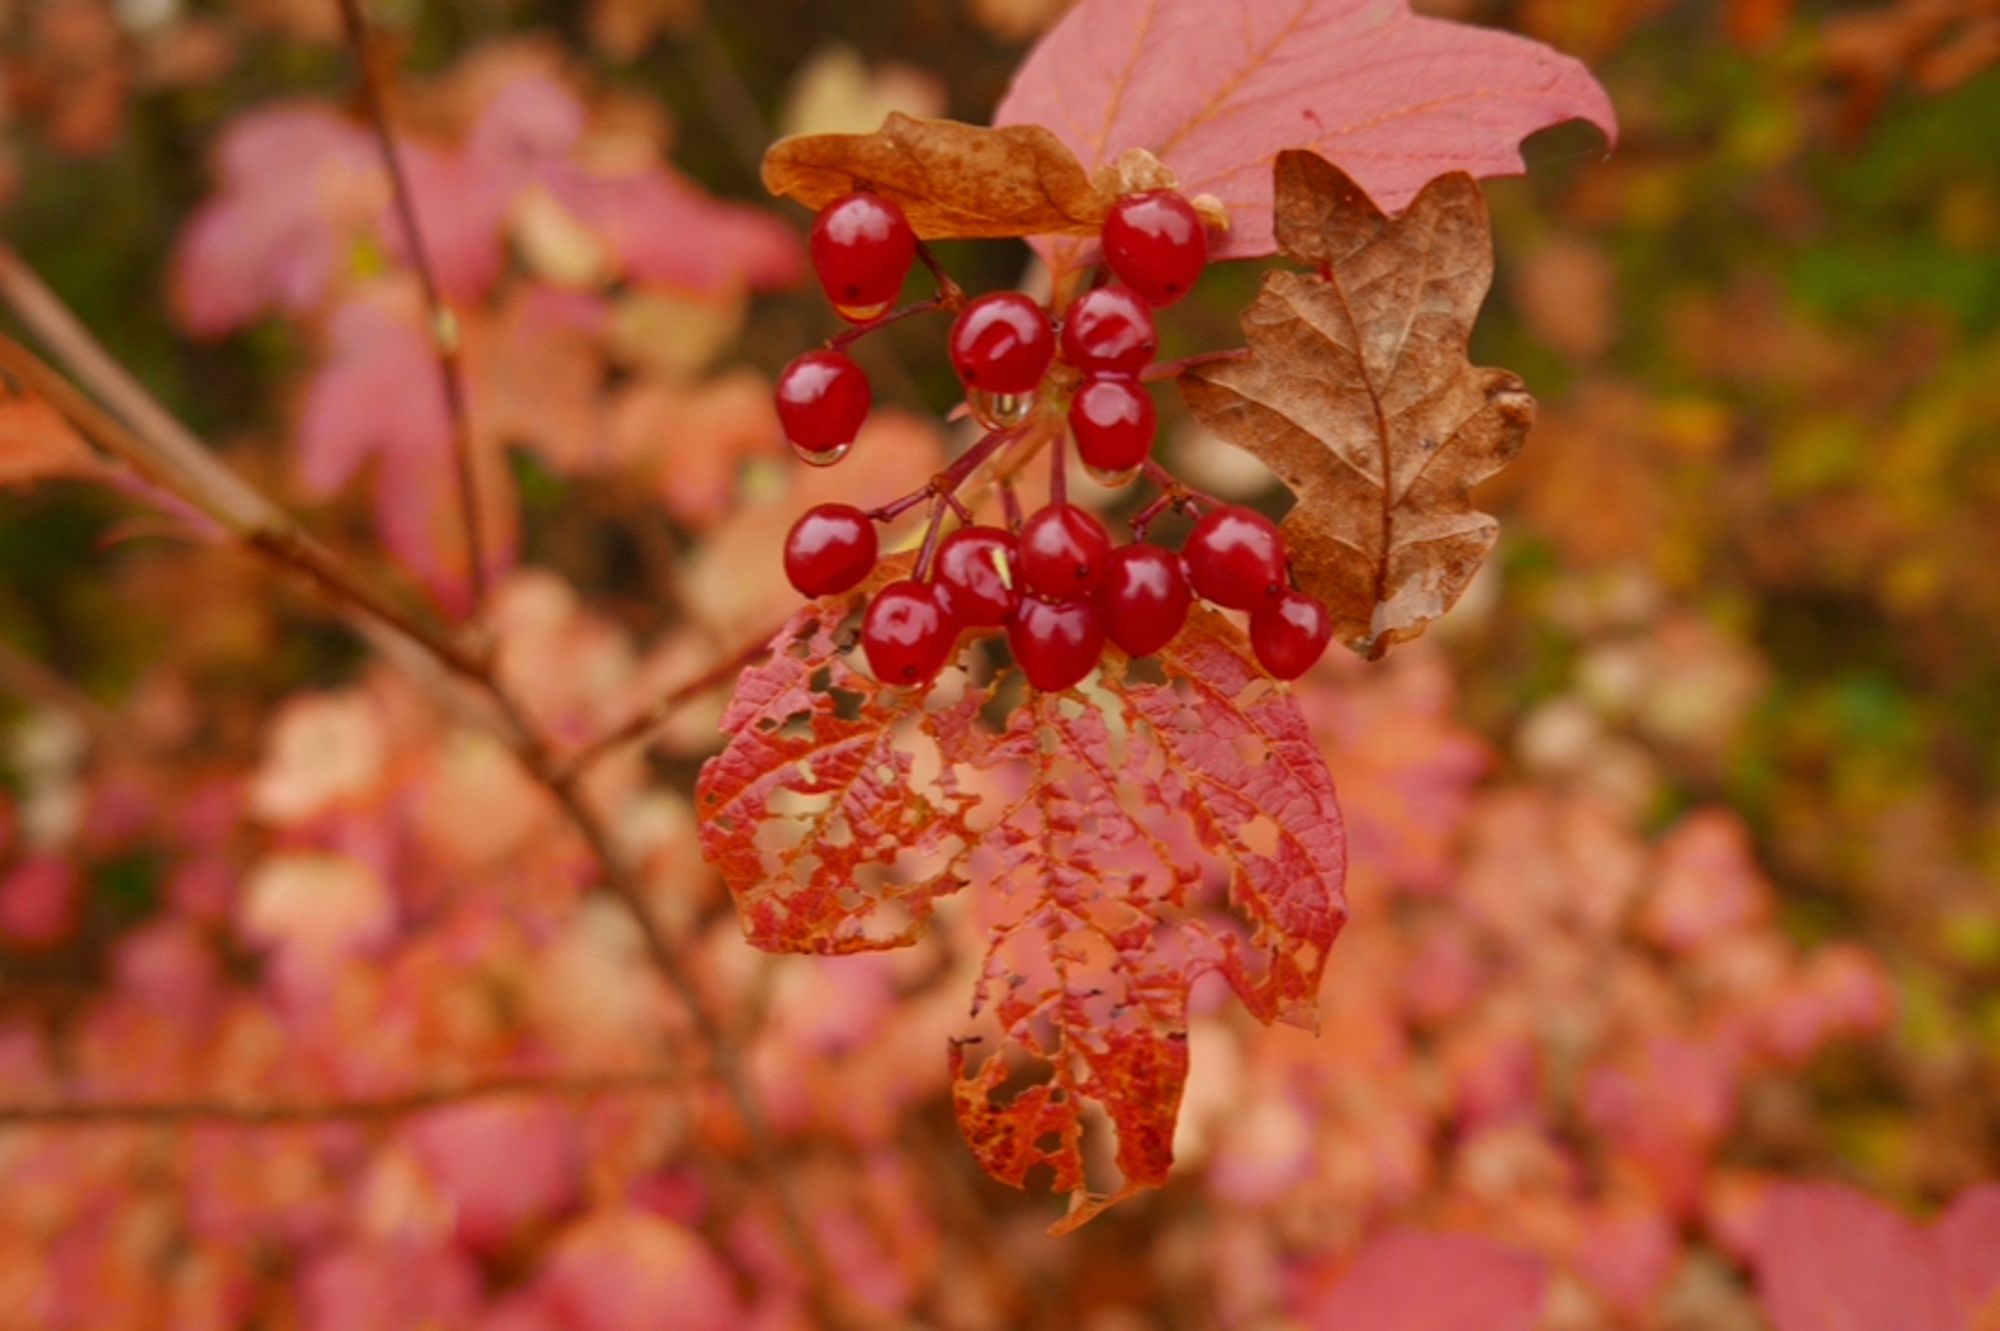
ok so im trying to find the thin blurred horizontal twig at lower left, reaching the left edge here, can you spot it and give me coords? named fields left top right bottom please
left=0, top=1069, right=688, bottom=1127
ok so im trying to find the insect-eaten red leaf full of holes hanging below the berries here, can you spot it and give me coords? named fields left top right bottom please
left=698, top=602, right=1346, bottom=1231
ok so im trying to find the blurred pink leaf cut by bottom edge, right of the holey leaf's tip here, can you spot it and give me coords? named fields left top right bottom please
left=1298, top=1229, right=1548, bottom=1331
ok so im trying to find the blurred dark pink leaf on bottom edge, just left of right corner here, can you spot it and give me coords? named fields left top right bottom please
left=1758, top=1183, right=1972, bottom=1331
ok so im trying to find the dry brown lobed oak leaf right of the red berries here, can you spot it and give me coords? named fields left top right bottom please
left=1180, top=152, right=1534, bottom=658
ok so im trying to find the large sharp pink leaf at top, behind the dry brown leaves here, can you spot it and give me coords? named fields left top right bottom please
left=994, top=0, right=1618, bottom=266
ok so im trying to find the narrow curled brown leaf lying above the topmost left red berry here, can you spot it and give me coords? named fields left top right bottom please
left=764, top=114, right=1112, bottom=240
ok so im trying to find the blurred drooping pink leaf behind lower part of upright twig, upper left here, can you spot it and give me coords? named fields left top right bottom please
left=298, top=288, right=516, bottom=608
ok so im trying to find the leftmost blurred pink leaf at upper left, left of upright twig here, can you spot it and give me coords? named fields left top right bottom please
left=172, top=104, right=388, bottom=338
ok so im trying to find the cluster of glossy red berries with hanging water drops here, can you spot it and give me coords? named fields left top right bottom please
left=778, top=190, right=1332, bottom=689
